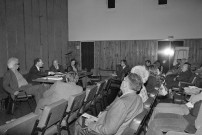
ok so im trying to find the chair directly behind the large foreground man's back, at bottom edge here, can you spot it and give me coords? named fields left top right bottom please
left=122, top=109, right=148, bottom=135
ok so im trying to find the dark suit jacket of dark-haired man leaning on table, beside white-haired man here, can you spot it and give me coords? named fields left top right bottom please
left=27, top=65, right=48, bottom=82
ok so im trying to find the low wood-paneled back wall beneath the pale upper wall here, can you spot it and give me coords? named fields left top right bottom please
left=68, top=39, right=202, bottom=69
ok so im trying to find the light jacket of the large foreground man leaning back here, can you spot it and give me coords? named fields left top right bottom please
left=88, top=92, right=143, bottom=135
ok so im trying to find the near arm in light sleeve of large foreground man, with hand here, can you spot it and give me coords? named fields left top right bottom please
left=89, top=100, right=127, bottom=134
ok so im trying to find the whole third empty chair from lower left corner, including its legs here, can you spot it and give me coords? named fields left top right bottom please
left=58, top=92, right=86, bottom=135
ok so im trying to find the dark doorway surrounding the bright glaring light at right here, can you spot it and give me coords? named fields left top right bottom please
left=158, top=41, right=184, bottom=73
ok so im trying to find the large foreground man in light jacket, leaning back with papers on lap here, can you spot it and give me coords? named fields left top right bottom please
left=75, top=73, right=143, bottom=135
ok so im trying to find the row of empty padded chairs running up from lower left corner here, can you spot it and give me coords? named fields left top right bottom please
left=0, top=76, right=114, bottom=135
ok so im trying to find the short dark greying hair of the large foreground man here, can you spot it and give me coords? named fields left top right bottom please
left=127, top=73, right=143, bottom=91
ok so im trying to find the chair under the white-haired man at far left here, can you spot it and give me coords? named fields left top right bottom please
left=8, top=90, right=34, bottom=114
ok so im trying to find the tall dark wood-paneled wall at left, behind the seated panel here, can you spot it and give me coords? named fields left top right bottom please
left=0, top=0, right=68, bottom=76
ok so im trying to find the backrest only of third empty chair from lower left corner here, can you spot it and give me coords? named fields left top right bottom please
left=66, top=92, right=86, bottom=123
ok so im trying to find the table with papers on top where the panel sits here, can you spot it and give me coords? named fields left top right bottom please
left=33, top=72, right=93, bottom=84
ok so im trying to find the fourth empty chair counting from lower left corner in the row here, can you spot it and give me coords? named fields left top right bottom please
left=82, top=85, right=98, bottom=114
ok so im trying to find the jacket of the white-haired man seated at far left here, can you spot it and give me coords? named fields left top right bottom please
left=3, top=69, right=20, bottom=95
